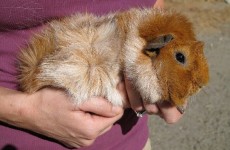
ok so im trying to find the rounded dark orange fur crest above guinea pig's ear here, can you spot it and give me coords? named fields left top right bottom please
left=139, top=10, right=196, bottom=41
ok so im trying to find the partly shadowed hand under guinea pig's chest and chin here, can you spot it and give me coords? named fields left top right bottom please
left=118, top=78, right=182, bottom=124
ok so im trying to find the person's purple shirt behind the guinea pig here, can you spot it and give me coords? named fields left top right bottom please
left=0, top=0, right=155, bottom=150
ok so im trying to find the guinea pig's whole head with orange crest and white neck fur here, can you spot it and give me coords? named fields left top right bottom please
left=125, top=10, right=209, bottom=107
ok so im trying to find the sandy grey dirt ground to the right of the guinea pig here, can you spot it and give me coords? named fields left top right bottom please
left=149, top=0, right=230, bottom=150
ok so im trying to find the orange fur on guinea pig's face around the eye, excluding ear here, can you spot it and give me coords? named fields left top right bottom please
left=151, top=41, right=209, bottom=106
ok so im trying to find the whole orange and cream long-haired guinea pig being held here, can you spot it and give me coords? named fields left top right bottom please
left=19, top=8, right=209, bottom=107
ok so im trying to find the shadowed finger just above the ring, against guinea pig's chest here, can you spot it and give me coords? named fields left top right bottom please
left=125, top=78, right=144, bottom=111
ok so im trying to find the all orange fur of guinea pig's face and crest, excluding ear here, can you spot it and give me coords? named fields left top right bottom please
left=129, top=9, right=209, bottom=106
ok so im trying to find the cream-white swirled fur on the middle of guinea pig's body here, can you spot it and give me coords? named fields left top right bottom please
left=39, top=15, right=123, bottom=105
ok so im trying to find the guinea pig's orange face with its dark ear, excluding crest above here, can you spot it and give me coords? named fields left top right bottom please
left=143, top=34, right=209, bottom=106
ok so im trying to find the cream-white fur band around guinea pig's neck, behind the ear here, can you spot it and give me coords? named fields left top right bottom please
left=124, top=10, right=161, bottom=103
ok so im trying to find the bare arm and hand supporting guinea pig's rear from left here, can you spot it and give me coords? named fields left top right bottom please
left=0, top=87, right=123, bottom=148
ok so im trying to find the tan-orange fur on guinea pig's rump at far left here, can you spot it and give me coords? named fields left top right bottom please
left=18, top=27, right=55, bottom=93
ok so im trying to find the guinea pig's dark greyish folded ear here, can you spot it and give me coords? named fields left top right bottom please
left=144, top=34, right=174, bottom=57
